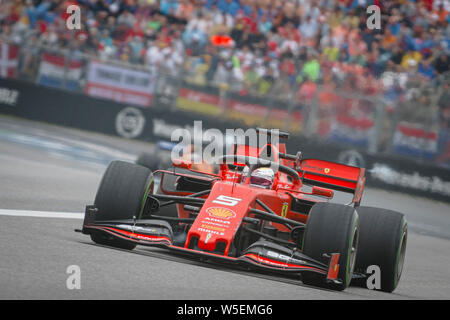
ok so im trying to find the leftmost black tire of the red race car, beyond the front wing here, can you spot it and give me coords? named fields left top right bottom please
left=91, top=161, right=153, bottom=250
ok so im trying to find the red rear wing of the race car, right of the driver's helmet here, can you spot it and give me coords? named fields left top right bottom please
left=299, top=159, right=366, bottom=205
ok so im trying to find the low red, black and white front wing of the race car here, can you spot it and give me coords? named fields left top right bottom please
left=81, top=206, right=341, bottom=283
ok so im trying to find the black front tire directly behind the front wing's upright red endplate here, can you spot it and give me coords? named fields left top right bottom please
left=302, top=203, right=359, bottom=291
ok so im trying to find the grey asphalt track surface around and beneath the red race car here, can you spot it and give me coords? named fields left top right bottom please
left=0, top=116, right=450, bottom=300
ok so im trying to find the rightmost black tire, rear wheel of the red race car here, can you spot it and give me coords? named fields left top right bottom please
left=352, top=207, right=408, bottom=292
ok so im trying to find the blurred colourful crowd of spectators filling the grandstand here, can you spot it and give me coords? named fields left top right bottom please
left=0, top=0, right=450, bottom=128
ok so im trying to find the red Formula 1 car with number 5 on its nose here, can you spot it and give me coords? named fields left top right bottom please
left=78, top=129, right=407, bottom=292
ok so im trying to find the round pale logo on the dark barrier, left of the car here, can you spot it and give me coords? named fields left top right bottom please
left=116, top=107, right=145, bottom=139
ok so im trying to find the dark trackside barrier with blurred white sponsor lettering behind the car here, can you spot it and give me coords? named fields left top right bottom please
left=0, top=78, right=450, bottom=202
